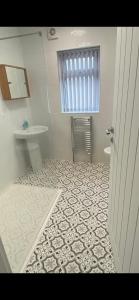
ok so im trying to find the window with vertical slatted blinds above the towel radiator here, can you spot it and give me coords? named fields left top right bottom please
left=57, top=47, right=100, bottom=113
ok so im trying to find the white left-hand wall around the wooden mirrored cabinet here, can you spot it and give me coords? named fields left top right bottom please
left=0, top=27, right=31, bottom=191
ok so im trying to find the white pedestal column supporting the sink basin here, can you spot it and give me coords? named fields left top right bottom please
left=27, top=139, right=42, bottom=172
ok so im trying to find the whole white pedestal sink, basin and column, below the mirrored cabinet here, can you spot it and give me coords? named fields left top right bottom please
left=14, top=125, right=48, bottom=171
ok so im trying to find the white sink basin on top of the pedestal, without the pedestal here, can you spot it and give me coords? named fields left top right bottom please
left=14, top=125, right=48, bottom=139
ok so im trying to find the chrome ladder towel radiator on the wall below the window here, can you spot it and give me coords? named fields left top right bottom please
left=71, top=116, right=92, bottom=163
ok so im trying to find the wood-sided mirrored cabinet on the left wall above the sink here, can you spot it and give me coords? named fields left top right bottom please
left=0, top=64, right=30, bottom=100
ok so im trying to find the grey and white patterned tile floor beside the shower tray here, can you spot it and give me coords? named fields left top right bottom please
left=17, top=160, right=115, bottom=273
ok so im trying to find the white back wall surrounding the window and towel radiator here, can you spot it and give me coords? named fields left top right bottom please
left=46, top=27, right=116, bottom=161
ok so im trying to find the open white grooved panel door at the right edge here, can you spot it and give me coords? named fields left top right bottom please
left=109, top=27, right=139, bottom=272
